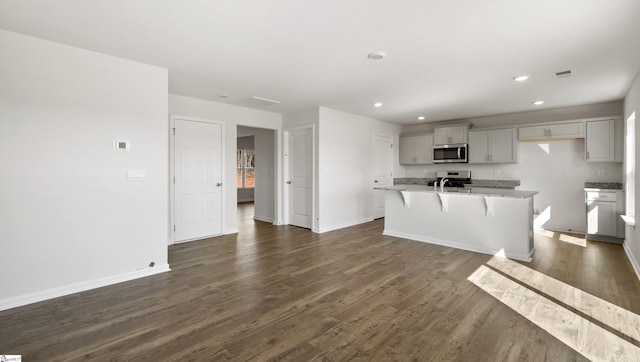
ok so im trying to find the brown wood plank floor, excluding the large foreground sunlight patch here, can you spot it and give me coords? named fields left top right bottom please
left=0, top=204, right=640, bottom=361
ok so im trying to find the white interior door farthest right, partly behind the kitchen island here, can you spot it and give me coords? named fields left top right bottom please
left=372, top=135, right=393, bottom=219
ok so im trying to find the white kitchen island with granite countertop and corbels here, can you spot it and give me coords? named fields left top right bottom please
left=376, top=185, right=538, bottom=261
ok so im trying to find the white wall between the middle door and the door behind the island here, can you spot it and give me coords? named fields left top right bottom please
left=318, top=107, right=402, bottom=232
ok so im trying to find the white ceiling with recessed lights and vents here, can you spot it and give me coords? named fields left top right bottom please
left=0, top=0, right=640, bottom=124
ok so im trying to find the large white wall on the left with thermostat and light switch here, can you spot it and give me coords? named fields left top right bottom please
left=0, top=30, right=168, bottom=310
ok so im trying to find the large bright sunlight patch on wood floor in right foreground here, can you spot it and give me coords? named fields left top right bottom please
left=467, top=257, right=640, bottom=361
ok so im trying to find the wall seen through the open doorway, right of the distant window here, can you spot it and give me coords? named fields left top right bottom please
left=238, top=126, right=276, bottom=223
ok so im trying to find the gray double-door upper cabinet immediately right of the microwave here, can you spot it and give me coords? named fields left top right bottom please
left=469, top=128, right=518, bottom=163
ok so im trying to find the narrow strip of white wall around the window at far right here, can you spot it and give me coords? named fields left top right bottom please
left=624, top=70, right=640, bottom=277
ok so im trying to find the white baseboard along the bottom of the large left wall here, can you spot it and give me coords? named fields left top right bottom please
left=0, top=264, right=171, bottom=311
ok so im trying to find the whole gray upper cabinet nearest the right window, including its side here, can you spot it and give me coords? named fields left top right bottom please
left=585, top=119, right=624, bottom=162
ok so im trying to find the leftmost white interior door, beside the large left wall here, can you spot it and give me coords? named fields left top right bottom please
left=174, top=119, right=223, bottom=242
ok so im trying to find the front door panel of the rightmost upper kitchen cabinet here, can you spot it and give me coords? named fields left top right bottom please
left=585, top=119, right=615, bottom=162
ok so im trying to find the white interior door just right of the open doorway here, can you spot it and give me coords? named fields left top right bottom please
left=285, top=128, right=313, bottom=228
